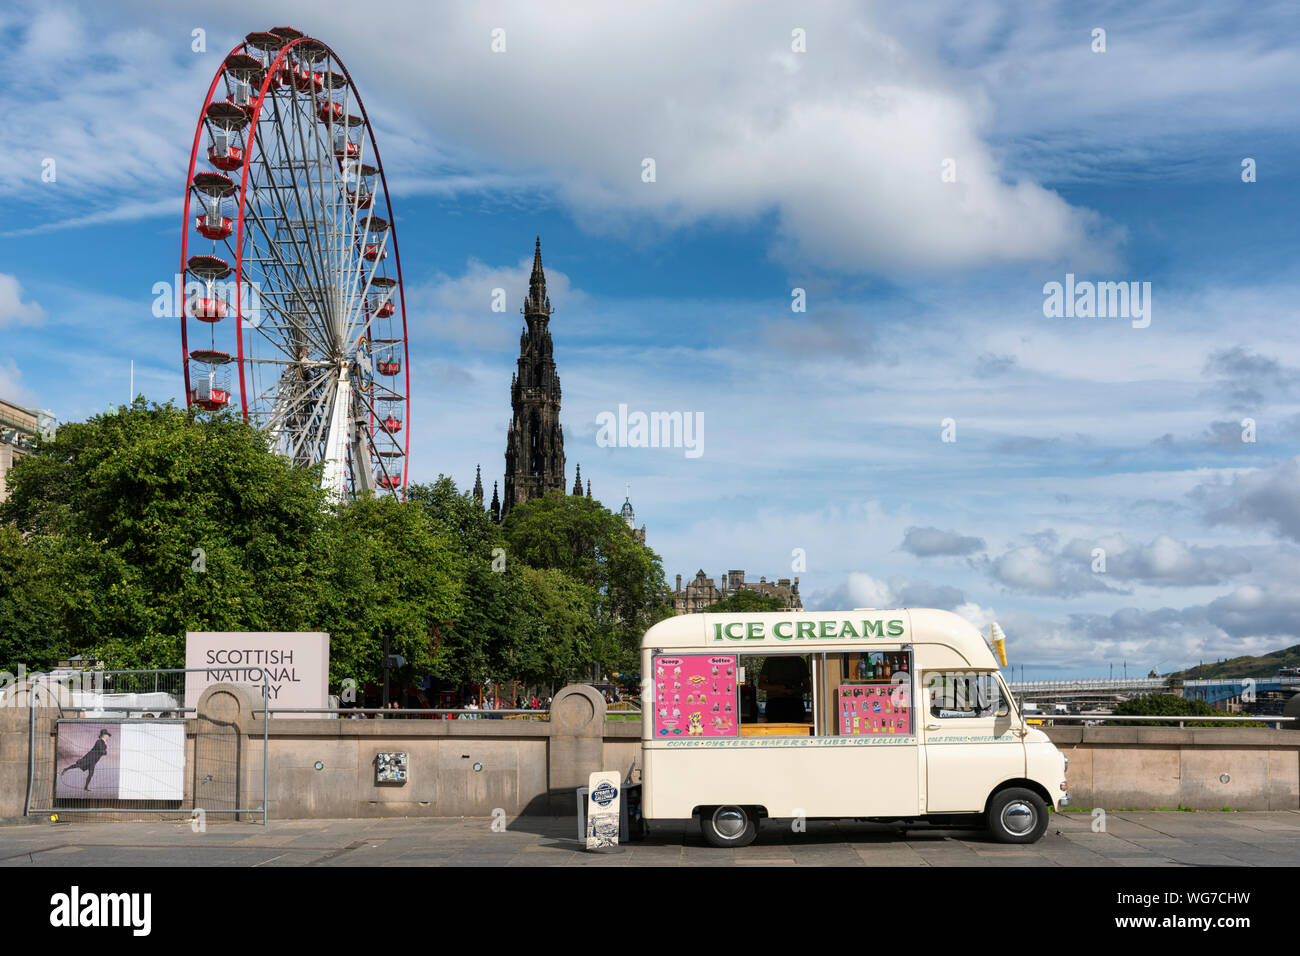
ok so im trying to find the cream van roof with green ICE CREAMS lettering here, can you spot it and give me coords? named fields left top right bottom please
left=641, top=607, right=997, bottom=667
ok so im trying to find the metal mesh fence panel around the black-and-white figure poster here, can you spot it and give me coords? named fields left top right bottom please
left=26, top=667, right=268, bottom=822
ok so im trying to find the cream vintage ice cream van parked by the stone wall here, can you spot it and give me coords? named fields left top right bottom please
left=641, top=609, right=1069, bottom=847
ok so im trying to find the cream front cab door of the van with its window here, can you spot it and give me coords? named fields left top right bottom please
left=918, top=670, right=1024, bottom=813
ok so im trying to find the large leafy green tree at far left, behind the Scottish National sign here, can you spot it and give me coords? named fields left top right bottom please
left=0, top=399, right=324, bottom=667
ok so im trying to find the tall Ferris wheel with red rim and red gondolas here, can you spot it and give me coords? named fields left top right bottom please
left=181, top=27, right=411, bottom=501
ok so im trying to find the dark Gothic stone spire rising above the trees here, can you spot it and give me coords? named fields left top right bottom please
left=501, top=237, right=564, bottom=519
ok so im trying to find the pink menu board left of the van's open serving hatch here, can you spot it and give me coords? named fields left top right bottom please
left=653, top=654, right=740, bottom=737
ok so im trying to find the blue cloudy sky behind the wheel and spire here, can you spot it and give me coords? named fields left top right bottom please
left=0, top=0, right=1300, bottom=679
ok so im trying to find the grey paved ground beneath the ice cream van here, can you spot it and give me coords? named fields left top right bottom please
left=0, top=810, right=1300, bottom=868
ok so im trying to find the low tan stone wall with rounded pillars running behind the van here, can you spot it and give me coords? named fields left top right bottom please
left=0, top=684, right=1300, bottom=819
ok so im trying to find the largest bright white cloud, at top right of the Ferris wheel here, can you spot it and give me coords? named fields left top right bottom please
left=377, top=3, right=1110, bottom=271
